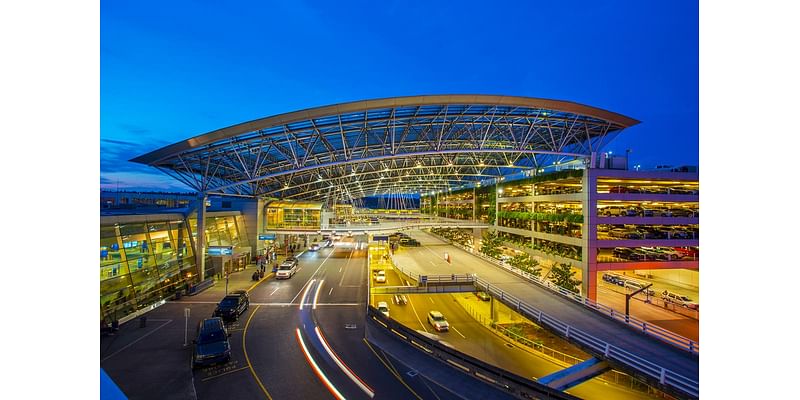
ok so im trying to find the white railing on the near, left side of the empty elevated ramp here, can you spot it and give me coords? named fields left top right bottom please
left=476, top=278, right=700, bottom=398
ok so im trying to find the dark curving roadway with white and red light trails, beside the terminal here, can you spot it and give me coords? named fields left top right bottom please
left=101, top=241, right=496, bottom=399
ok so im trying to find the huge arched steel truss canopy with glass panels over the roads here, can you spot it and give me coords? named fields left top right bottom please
left=131, top=95, right=639, bottom=203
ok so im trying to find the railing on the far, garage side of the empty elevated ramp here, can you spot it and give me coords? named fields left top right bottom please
left=437, top=235, right=700, bottom=354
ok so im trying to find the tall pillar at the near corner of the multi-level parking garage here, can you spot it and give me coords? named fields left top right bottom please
left=581, top=169, right=597, bottom=300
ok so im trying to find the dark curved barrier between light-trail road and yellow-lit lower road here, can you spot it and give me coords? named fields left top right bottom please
left=367, top=306, right=578, bottom=400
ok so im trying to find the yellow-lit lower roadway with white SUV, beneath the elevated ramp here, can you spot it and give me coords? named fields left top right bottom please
left=371, top=270, right=649, bottom=399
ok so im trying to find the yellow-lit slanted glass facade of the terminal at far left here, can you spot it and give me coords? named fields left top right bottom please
left=100, top=215, right=248, bottom=322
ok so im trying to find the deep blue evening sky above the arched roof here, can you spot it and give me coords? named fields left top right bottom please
left=100, top=0, right=698, bottom=191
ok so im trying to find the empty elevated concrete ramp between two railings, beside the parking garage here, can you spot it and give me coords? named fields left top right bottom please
left=394, top=231, right=699, bottom=381
